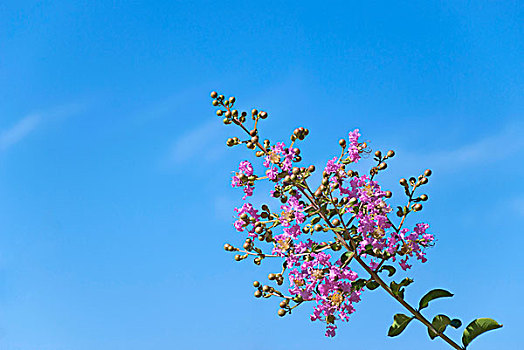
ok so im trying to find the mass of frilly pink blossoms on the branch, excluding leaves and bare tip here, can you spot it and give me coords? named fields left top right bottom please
left=227, top=129, right=434, bottom=337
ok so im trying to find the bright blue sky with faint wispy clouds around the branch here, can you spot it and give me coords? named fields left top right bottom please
left=0, top=0, right=524, bottom=350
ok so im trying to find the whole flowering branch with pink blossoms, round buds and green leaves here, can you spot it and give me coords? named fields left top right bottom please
left=211, top=92, right=502, bottom=349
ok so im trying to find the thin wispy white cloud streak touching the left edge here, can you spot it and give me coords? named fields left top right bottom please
left=0, top=104, right=83, bottom=151
